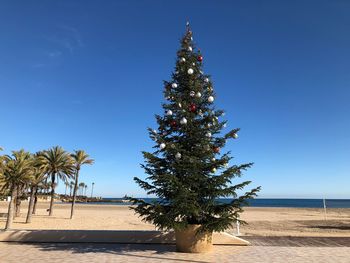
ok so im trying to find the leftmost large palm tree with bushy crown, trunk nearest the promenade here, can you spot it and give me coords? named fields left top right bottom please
left=2, top=150, right=33, bottom=230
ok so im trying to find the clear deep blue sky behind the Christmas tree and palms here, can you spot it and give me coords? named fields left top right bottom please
left=0, top=0, right=350, bottom=198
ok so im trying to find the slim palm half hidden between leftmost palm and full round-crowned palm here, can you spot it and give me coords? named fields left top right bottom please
left=26, top=153, right=46, bottom=223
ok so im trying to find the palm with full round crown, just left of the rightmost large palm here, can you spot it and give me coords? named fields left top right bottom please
left=41, top=146, right=74, bottom=216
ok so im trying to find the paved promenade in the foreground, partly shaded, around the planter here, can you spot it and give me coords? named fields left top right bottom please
left=0, top=237, right=350, bottom=263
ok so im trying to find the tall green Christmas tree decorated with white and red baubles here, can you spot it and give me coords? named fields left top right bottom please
left=131, top=24, right=260, bottom=235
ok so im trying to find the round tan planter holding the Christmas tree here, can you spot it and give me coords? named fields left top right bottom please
left=175, top=225, right=213, bottom=253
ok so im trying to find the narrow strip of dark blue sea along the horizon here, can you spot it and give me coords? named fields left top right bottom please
left=89, top=198, right=350, bottom=208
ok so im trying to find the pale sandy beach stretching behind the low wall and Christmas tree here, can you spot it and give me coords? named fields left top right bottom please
left=0, top=202, right=350, bottom=237
